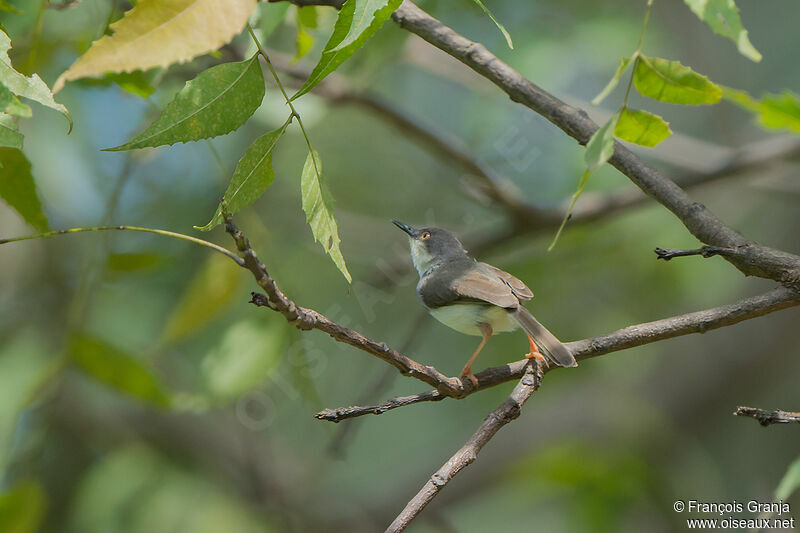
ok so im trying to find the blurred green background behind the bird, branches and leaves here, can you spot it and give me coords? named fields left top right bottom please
left=0, top=0, right=800, bottom=533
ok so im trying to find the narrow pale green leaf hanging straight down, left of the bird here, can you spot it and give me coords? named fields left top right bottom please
left=300, top=151, right=353, bottom=283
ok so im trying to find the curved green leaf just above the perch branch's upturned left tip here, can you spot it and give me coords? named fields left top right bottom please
left=195, top=122, right=289, bottom=231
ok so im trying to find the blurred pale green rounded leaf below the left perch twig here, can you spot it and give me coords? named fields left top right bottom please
left=203, top=320, right=286, bottom=399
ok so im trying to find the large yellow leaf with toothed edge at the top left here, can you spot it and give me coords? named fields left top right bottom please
left=53, top=0, right=256, bottom=92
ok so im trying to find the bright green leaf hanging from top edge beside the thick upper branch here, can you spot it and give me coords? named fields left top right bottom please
left=292, top=0, right=403, bottom=100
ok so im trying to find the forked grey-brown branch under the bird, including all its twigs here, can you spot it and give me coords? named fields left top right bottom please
left=224, top=209, right=800, bottom=532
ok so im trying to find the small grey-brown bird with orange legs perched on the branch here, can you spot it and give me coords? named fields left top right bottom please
left=393, top=220, right=578, bottom=385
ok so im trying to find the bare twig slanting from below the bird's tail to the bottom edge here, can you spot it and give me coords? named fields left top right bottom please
left=386, top=359, right=542, bottom=533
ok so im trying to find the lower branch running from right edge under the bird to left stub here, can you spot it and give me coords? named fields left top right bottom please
left=316, top=287, right=800, bottom=422
